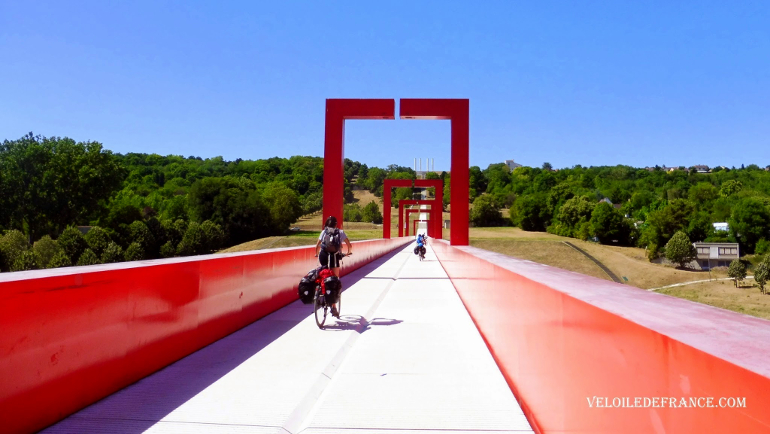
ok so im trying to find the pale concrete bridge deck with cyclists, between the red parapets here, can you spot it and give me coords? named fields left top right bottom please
left=43, top=244, right=533, bottom=434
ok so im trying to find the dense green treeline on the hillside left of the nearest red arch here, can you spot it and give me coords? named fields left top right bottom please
left=0, top=133, right=382, bottom=271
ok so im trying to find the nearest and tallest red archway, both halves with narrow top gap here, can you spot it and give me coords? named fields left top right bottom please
left=323, top=98, right=470, bottom=246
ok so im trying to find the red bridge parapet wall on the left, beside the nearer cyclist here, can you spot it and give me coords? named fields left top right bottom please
left=0, top=239, right=409, bottom=433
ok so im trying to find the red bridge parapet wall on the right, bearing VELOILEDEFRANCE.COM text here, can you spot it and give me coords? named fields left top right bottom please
left=431, top=241, right=770, bottom=434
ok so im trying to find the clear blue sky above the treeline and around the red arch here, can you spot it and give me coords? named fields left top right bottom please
left=0, top=0, right=770, bottom=169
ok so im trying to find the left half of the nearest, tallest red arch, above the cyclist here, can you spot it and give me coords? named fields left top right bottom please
left=323, top=99, right=396, bottom=229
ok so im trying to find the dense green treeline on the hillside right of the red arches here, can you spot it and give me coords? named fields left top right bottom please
left=470, top=164, right=770, bottom=258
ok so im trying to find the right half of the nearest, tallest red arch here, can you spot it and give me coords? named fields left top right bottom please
left=399, top=98, right=470, bottom=246
